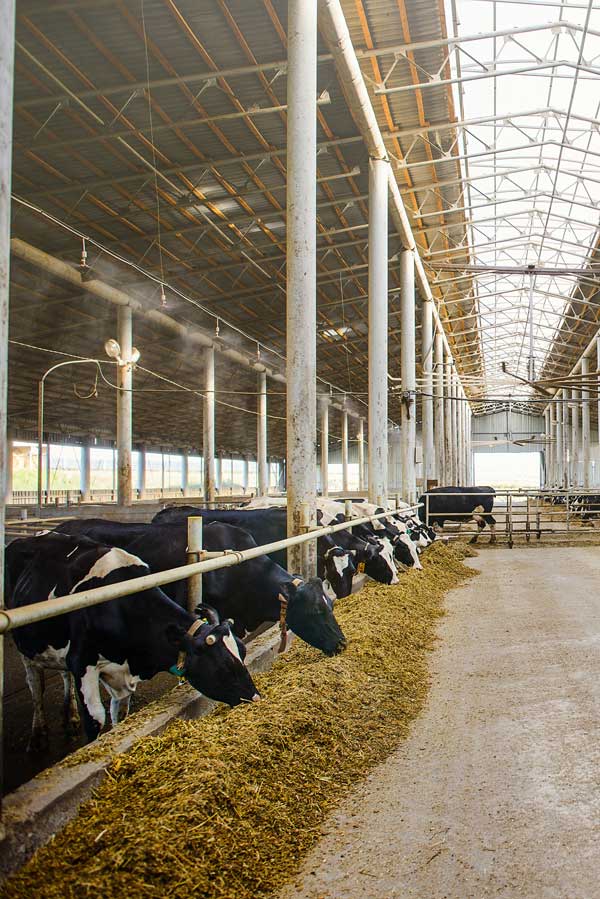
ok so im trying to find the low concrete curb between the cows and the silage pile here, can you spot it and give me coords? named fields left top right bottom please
left=0, top=625, right=293, bottom=878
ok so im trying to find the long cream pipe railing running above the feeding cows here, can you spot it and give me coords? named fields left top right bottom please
left=0, top=504, right=419, bottom=634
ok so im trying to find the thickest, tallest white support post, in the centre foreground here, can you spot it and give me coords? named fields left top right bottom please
left=286, top=0, right=317, bottom=578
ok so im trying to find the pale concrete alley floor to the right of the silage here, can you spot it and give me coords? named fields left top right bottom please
left=281, top=546, right=600, bottom=899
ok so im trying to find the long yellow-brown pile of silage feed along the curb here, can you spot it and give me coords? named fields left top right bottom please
left=0, top=543, right=473, bottom=899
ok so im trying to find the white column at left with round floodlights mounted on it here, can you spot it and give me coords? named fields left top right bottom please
left=117, top=306, right=133, bottom=506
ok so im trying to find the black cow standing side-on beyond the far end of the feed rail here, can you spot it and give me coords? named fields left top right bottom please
left=419, top=487, right=496, bottom=543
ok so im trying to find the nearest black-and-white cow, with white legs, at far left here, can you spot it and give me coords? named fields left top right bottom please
left=6, top=533, right=260, bottom=745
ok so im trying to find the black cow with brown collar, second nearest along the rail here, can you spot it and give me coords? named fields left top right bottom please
left=59, top=519, right=346, bottom=656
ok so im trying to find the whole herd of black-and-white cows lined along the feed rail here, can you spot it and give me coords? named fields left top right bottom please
left=5, top=487, right=494, bottom=748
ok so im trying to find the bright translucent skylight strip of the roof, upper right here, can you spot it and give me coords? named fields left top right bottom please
left=439, top=0, right=600, bottom=408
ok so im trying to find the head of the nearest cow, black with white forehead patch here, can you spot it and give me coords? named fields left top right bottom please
left=170, top=607, right=260, bottom=706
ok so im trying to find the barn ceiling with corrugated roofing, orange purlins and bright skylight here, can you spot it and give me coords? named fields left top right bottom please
left=11, top=0, right=600, bottom=455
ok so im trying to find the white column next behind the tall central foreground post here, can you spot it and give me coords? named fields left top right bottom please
left=368, top=158, right=392, bottom=503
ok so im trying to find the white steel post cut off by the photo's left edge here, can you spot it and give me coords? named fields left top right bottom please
left=0, top=0, right=15, bottom=824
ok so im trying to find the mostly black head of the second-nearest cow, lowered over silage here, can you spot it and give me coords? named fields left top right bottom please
left=279, top=577, right=346, bottom=656
